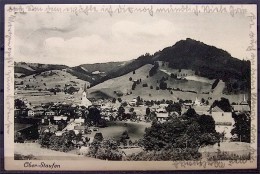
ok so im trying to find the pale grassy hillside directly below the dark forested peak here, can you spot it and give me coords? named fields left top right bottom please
left=89, top=64, right=230, bottom=101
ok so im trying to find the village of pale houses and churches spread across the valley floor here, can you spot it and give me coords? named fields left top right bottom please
left=14, top=80, right=250, bottom=159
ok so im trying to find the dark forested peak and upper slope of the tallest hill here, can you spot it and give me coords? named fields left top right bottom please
left=93, top=38, right=250, bottom=89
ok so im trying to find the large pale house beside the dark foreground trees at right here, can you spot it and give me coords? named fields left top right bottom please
left=211, top=106, right=235, bottom=138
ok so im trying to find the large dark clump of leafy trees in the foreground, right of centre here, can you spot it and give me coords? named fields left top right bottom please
left=126, top=109, right=220, bottom=160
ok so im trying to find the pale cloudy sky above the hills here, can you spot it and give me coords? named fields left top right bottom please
left=15, top=4, right=252, bottom=66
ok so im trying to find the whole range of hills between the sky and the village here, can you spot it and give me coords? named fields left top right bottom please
left=15, top=38, right=251, bottom=103
